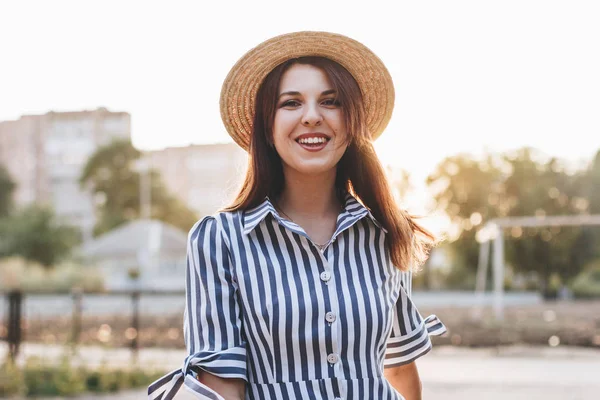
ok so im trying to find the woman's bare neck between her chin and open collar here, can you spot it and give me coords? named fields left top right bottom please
left=276, top=170, right=341, bottom=219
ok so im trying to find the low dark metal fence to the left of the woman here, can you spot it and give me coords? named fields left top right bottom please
left=0, top=290, right=185, bottom=360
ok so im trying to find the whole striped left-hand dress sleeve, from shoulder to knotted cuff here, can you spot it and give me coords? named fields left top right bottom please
left=148, top=217, right=247, bottom=400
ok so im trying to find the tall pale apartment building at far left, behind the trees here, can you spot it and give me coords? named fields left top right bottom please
left=0, top=108, right=131, bottom=239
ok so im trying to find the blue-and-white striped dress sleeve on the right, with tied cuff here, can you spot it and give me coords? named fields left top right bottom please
left=384, top=272, right=446, bottom=368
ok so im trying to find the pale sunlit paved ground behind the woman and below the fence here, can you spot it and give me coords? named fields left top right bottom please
left=2, top=344, right=600, bottom=400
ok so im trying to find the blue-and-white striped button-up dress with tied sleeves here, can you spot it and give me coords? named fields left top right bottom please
left=148, top=195, right=446, bottom=400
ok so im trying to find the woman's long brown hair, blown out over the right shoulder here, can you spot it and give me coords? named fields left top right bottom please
left=224, top=57, right=434, bottom=271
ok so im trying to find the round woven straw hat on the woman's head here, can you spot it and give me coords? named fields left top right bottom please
left=220, top=32, right=394, bottom=151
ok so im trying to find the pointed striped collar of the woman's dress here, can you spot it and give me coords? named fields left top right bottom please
left=243, top=193, right=387, bottom=235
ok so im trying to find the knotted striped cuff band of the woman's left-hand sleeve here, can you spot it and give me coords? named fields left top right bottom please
left=148, top=347, right=246, bottom=400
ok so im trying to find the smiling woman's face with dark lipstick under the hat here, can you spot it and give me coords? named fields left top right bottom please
left=273, top=64, right=347, bottom=175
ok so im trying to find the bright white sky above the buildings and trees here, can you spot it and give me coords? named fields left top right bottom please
left=0, top=0, right=600, bottom=184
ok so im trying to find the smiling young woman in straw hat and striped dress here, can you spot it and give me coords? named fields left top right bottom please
left=149, top=32, right=445, bottom=400
